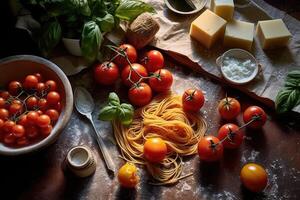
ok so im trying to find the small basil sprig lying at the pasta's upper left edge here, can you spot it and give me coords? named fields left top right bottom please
left=98, top=92, right=134, bottom=125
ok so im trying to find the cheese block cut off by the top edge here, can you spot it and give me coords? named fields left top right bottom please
left=210, top=0, right=234, bottom=21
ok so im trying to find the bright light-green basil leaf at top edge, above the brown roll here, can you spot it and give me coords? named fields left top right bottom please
left=115, top=0, right=155, bottom=21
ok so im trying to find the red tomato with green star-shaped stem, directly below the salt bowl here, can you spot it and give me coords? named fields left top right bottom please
left=218, top=97, right=241, bottom=120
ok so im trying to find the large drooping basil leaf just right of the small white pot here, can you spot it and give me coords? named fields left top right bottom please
left=80, top=21, right=103, bottom=61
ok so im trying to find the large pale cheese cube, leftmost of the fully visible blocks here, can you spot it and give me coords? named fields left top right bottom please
left=190, top=9, right=226, bottom=49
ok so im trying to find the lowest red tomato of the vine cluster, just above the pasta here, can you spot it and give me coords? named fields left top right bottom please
left=128, top=83, right=152, bottom=106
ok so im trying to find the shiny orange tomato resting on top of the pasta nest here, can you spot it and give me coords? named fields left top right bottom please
left=144, top=137, right=168, bottom=163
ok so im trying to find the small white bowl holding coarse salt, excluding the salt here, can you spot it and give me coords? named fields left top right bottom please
left=216, top=49, right=261, bottom=85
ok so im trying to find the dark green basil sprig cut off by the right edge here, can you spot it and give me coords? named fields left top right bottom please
left=275, top=70, right=300, bottom=113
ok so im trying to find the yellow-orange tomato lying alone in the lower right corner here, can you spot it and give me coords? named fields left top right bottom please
left=240, top=163, right=268, bottom=192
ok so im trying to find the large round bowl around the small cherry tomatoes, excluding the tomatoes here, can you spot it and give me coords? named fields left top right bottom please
left=0, top=55, right=73, bottom=156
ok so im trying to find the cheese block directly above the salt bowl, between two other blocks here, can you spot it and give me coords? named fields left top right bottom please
left=224, top=20, right=254, bottom=50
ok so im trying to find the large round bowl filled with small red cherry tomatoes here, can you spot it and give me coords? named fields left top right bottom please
left=0, top=55, right=73, bottom=156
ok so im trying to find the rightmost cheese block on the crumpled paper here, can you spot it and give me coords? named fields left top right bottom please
left=256, top=19, right=291, bottom=49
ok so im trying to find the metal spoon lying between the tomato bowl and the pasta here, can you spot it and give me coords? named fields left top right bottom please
left=74, top=87, right=115, bottom=173
